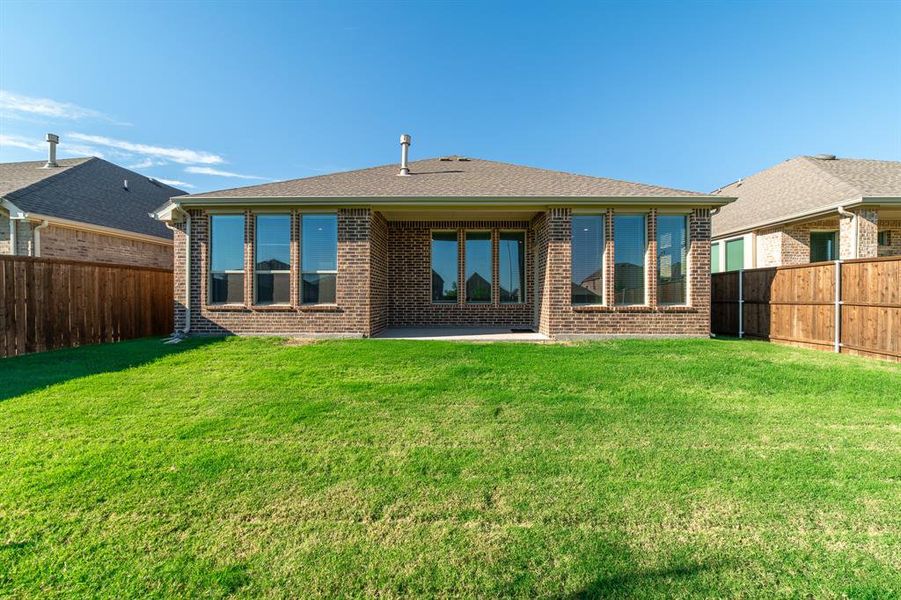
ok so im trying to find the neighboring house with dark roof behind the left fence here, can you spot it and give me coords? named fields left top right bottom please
left=0, top=137, right=185, bottom=268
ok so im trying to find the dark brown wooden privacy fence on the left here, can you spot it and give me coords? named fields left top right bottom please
left=0, top=256, right=173, bottom=356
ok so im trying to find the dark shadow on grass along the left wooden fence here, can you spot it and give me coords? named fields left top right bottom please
left=0, top=338, right=222, bottom=402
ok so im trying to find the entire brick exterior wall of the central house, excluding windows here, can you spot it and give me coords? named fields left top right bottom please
left=174, top=208, right=710, bottom=338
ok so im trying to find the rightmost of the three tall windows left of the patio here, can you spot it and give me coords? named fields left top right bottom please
left=300, top=215, right=338, bottom=304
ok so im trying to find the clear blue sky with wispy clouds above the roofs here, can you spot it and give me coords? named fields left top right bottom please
left=0, top=0, right=901, bottom=192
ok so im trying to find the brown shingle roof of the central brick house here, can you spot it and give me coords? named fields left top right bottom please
left=185, top=157, right=705, bottom=199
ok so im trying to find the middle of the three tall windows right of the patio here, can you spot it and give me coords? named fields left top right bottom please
left=613, top=215, right=647, bottom=306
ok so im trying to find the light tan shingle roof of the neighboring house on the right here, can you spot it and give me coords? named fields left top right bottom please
left=713, top=156, right=901, bottom=237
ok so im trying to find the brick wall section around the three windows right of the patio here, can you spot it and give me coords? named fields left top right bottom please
left=534, top=209, right=710, bottom=338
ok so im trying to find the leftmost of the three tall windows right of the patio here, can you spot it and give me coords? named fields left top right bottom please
left=571, top=215, right=604, bottom=304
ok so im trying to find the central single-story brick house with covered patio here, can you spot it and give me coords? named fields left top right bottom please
left=156, top=138, right=730, bottom=337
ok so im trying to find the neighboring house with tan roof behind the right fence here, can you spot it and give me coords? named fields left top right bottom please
left=712, top=155, right=901, bottom=272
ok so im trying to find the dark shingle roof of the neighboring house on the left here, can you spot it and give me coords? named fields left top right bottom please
left=0, top=158, right=185, bottom=238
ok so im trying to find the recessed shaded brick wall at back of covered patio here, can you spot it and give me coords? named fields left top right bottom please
left=388, top=221, right=532, bottom=327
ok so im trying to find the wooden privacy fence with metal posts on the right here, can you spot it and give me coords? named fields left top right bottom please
left=711, top=256, right=901, bottom=361
